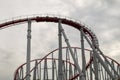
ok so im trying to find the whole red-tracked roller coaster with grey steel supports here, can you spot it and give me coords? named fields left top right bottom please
left=0, top=15, right=120, bottom=80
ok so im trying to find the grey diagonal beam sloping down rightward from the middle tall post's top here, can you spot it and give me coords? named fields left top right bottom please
left=60, top=19, right=85, bottom=80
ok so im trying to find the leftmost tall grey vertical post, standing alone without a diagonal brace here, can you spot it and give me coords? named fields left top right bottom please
left=26, top=19, right=31, bottom=80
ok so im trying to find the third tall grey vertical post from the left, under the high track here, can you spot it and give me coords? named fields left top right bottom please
left=80, top=27, right=86, bottom=80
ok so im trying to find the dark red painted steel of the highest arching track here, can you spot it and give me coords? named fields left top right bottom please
left=0, top=16, right=96, bottom=43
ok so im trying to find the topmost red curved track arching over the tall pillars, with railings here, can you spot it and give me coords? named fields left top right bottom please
left=0, top=15, right=99, bottom=46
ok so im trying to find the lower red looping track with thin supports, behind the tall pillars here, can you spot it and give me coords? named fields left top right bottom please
left=14, top=47, right=120, bottom=80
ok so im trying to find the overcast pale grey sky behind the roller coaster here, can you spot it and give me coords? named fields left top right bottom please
left=0, top=0, right=120, bottom=80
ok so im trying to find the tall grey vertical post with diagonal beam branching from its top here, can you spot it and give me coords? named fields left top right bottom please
left=58, top=20, right=63, bottom=80
